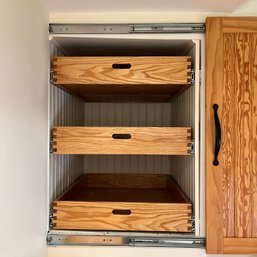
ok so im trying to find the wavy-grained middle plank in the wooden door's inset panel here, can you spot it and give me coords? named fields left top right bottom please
left=234, top=33, right=252, bottom=237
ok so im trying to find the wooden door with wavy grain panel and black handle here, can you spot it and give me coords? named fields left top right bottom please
left=206, top=17, right=257, bottom=253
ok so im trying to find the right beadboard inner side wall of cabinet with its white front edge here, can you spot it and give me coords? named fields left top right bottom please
left=168, top=43, right=196, bottom=230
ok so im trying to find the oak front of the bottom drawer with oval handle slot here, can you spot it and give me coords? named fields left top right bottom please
left=54, top=201, right=192, bottom=232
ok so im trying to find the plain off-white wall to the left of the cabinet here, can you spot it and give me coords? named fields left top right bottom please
left=0, top=0, right=48, bottom=257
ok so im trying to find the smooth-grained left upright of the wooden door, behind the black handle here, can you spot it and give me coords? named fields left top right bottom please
left=205, top=18, right=224, bottom=253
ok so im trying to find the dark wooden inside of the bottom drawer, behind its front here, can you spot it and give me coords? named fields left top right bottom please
left=58, top=174, right=187, bottom=204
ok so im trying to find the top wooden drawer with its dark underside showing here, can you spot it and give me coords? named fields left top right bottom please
left=53, top=56, right=191, bottom=101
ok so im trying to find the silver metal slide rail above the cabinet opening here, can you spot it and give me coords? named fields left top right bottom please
left=49, top=23, right=205, bottom=35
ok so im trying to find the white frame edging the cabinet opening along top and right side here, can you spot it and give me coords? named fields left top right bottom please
left=49, top=32, right=205, bottom=247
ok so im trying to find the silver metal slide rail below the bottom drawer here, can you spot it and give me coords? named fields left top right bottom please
left=47, top=230, right=205, bottom=248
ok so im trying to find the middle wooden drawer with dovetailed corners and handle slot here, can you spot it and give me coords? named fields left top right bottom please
left=53, top=127, right=191, bottom=155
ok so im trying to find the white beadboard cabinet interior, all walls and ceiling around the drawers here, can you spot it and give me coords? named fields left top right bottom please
left=49, top=36, right=200, bottom=236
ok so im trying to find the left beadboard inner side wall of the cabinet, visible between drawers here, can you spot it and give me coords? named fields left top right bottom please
left=49, top=41, right=84, bottom=206
